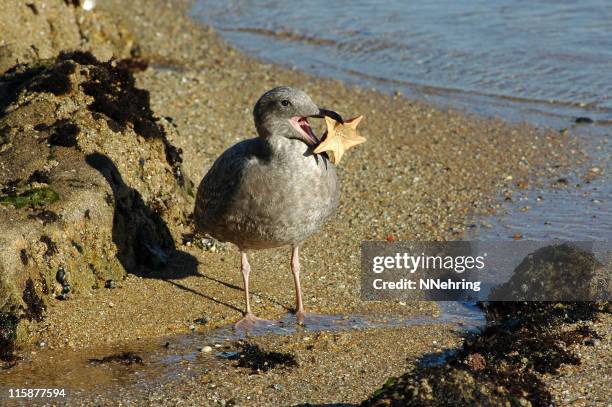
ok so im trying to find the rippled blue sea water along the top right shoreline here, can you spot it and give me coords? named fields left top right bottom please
left=193, top=0, right=612, bottom=119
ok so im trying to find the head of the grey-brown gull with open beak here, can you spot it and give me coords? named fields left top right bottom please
left=253, top=86, right=342, bottom=145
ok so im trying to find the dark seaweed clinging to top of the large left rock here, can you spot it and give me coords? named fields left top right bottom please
left=0, top=51, right=185, bottom=187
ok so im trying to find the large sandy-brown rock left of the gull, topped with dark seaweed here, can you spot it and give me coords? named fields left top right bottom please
left=0, top=50, right=193, bottom=356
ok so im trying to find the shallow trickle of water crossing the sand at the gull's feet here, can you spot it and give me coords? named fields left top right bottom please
left=0, top=302, right=485, bottom=404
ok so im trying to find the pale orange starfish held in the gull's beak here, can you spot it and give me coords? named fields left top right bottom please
left=314, top=116, right=366, bottom=164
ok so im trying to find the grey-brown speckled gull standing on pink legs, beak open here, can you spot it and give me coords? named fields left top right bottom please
left=194, top=86, right=343, bottom=329
